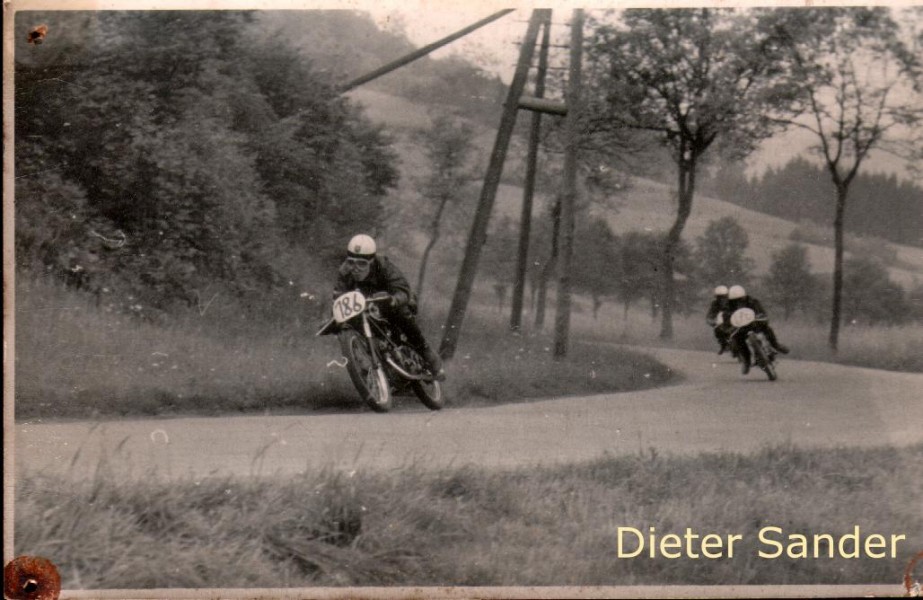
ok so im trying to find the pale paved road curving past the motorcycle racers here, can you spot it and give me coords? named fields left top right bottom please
left=15, top=350, right=923, bottom=478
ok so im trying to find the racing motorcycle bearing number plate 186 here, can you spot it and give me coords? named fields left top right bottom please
left=316, top=290, right=445, bottom=412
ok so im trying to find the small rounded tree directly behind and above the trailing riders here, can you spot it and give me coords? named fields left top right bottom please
left=695, top=217, right=753, bottom=288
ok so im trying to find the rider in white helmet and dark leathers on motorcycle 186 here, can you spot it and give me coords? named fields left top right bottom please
left=333, top=234, right=445, bottom=381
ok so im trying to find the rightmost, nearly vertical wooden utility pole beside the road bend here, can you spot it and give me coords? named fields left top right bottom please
left=554, top=8, right=583, bottom=359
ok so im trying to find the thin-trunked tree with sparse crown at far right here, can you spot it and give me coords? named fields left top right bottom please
left=767, top=7, right=923, bottom=352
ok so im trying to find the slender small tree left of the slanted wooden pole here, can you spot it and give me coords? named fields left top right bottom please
left=416, top=114, right=477, bottom=297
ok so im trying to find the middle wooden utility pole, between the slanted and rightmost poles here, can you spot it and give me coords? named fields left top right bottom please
left=510, top=10, right=551, bottom=331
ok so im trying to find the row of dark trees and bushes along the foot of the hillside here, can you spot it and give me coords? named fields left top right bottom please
left=498, top=215, right=923, bottom=327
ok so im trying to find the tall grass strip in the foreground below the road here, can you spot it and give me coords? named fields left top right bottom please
left=15, top=445, right=923, bottom=588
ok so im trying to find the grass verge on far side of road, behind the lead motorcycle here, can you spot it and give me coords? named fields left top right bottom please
left=16, top=281, right=672, bottom=418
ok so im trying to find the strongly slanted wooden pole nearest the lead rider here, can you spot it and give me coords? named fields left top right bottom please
left=439, top=9, right=548, bottom=359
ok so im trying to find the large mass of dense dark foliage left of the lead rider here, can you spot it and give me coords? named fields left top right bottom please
left=15, top=11, right=397, bottom=309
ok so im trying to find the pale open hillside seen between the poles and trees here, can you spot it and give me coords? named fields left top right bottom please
left=350, top=89, right=923, bottom=288
